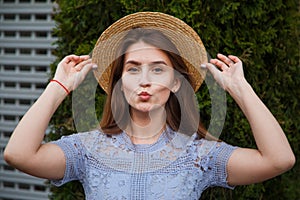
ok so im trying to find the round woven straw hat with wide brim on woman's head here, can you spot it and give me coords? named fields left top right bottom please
left=92, top=12, right=207, bottom=93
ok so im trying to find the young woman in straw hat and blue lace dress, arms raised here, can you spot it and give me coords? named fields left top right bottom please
left=4, top=12, right=295, bottom=199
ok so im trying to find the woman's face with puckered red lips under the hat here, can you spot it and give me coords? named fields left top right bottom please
left=122, top=42, right=180, bottom=112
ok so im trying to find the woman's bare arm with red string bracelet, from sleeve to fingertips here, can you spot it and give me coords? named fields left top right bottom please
left=4, top=55, right=93, bottom=179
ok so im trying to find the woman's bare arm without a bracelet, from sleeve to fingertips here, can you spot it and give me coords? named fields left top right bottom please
left=206, top=54, right=295, bottom=185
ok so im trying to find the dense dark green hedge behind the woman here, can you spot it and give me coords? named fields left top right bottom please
left=48, top=0, right=300, bottom=200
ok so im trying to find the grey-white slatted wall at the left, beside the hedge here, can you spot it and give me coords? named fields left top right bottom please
left=0, top=0, right=55, bottom=200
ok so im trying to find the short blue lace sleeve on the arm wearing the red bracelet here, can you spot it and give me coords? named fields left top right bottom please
left=51, top=134, right=84, bottom=186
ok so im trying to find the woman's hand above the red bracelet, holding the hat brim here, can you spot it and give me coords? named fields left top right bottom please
left=53, top=55, right=97, bottom=91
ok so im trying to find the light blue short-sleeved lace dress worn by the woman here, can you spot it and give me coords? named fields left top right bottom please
left=52, top=128, right=236, bottom=200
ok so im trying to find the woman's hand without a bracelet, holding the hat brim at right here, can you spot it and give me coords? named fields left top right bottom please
left=206, top=53, right=245, bottom=92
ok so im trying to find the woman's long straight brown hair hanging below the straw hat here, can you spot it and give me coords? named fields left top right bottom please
left=100, top=28, right=208, bottom=138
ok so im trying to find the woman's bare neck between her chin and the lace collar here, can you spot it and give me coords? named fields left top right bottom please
left=126, top=107, right=166, bottom=144
